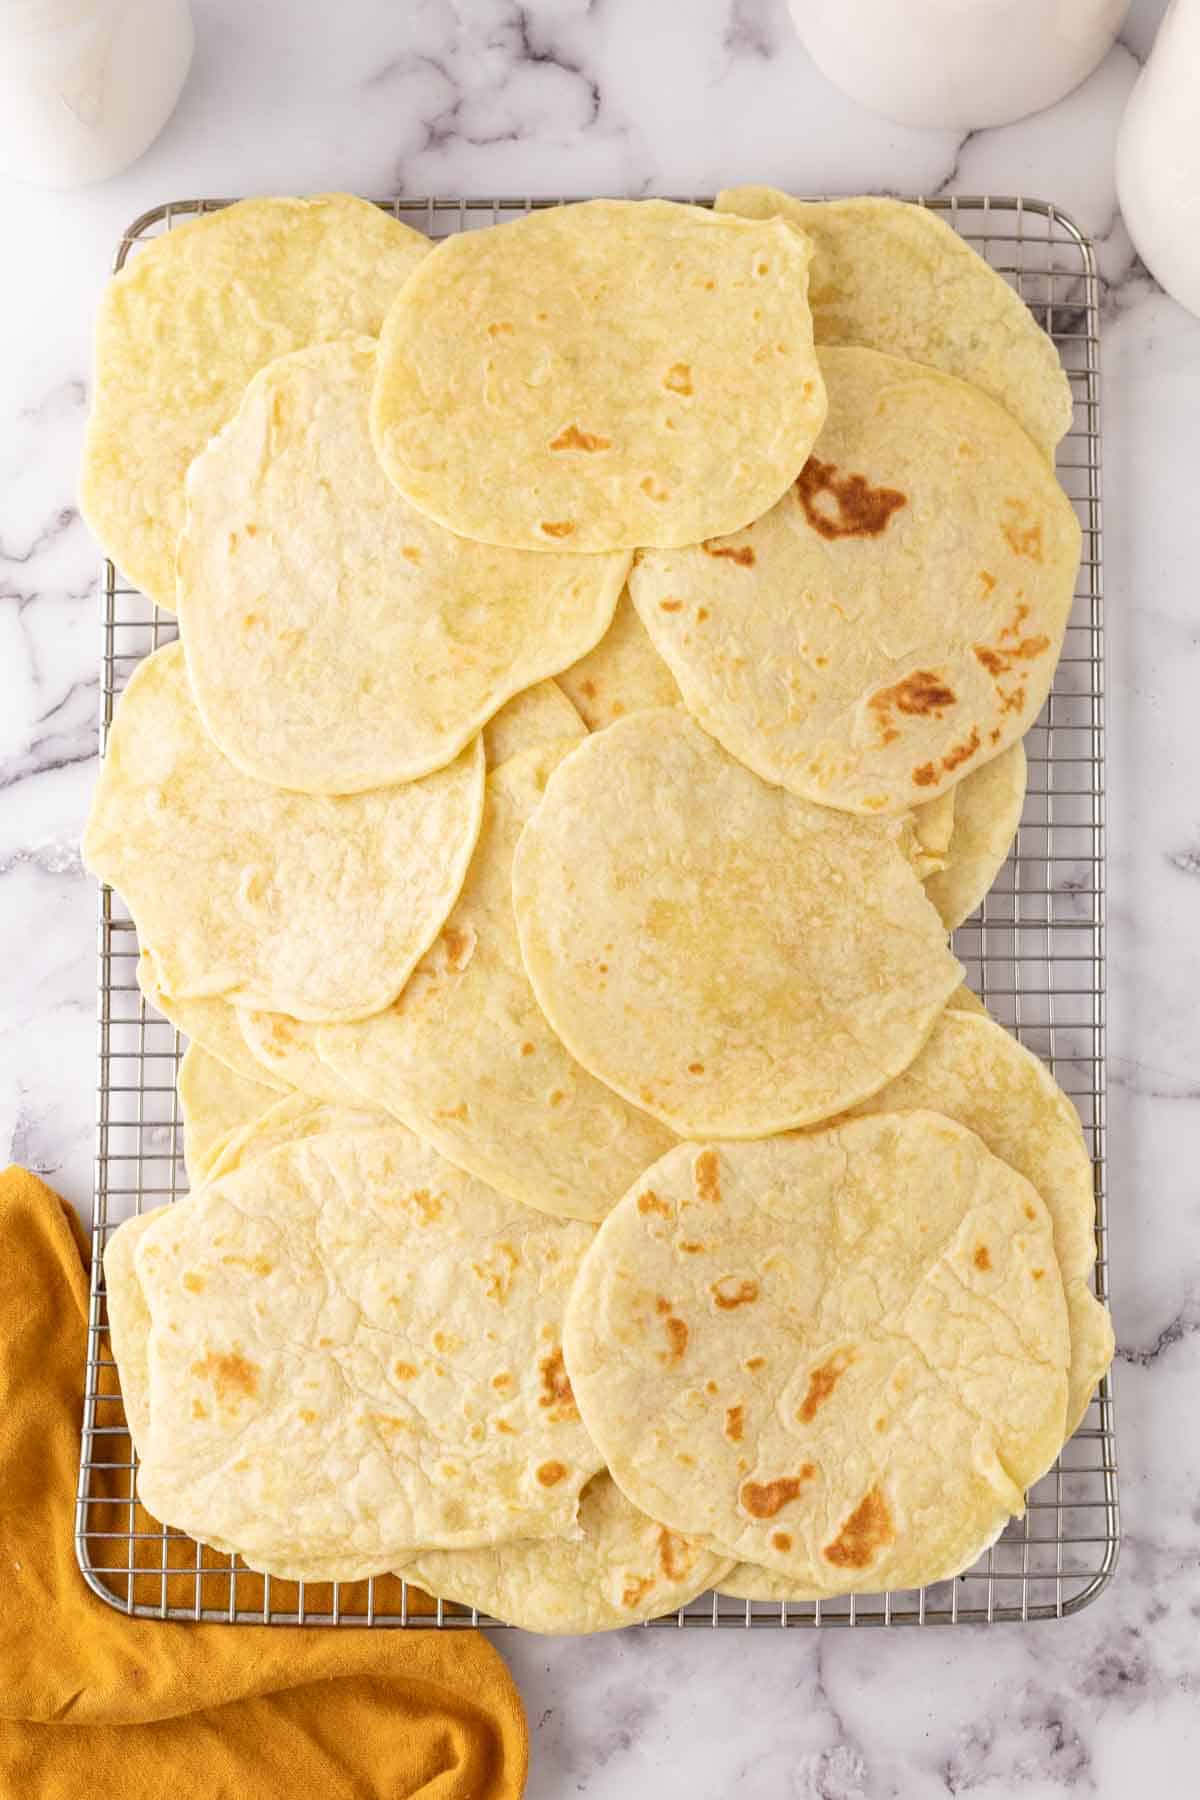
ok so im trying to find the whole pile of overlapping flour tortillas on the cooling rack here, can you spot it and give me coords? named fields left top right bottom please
left=83, top=189, right=1112, bottom=1631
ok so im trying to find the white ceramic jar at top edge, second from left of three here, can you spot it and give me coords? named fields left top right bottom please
left=790, top=0, right=1130, bottom=131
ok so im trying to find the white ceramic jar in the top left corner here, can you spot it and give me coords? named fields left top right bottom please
left=0, top=0, right=194, bottom=187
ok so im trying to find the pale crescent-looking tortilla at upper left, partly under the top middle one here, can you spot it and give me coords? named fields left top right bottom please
left=178, top=338, right=630, bottom=794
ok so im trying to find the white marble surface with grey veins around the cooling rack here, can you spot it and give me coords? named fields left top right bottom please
left=0, top=0, right=1200, bottom=1800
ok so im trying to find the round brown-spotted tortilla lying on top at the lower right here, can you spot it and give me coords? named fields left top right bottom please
left=563, top=1112, right=1069, bottom=1595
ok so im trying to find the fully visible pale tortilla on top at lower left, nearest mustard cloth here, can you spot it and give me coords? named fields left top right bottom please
left=113, top=1125, right=601, bottom=1580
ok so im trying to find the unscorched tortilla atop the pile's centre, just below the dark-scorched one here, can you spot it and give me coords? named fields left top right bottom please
left=510, top=709, right=963, bottom=1138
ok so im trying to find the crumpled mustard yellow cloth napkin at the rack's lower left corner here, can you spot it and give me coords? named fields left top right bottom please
left=0, top=1168, right=529, bottom=1800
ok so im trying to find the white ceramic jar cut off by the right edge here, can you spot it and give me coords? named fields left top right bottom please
left=1117, top=0, right=1200, bottom=319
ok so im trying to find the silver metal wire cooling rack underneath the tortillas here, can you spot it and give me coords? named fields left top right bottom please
left=76, top=196, right=1119, bottom=1629
